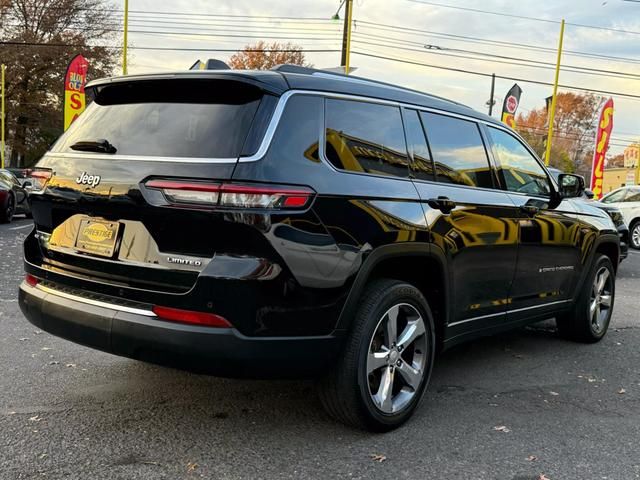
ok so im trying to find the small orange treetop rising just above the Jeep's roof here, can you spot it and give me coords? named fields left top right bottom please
left=228, top=41, right=311, bottom=70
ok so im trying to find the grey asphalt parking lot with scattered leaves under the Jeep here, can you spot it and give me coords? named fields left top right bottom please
left=0, top=218, right=640, bottom=480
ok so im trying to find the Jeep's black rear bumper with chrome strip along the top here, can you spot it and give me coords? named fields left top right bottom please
left=19, top=282, right=341, bottom=378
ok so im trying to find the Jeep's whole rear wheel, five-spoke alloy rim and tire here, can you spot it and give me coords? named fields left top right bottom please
left=320, top=279, right=435, bottom=432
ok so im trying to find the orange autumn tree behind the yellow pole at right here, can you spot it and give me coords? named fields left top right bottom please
left=516, top=92, right=601, bottom=175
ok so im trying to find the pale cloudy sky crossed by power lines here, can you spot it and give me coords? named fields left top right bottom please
left=116, top=0, right=640, bottom=155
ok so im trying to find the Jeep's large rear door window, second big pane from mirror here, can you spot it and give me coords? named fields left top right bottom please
left=420, top=112, right=493, bottom=188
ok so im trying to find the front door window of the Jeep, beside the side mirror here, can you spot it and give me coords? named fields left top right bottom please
left=489, top=128, right=550, bottom=196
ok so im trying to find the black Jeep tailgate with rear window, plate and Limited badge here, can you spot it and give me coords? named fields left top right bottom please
left=27, top=79, right=277, bottom=292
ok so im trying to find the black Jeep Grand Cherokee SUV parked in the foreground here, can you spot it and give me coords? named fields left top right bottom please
left=20, top=66, right=620, bottom=431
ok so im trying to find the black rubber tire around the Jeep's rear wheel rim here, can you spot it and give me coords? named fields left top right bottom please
left=319, top=279, right=435, bottom=432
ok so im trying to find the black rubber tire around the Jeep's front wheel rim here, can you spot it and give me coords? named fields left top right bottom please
left=556, top=254, right=616, bottom=343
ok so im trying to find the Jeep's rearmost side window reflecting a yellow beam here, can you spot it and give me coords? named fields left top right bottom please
left=325, top=99, right=409, bottom=177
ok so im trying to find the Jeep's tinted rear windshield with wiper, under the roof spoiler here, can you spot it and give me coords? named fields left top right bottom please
left=52, top=79, right=262, bottom=158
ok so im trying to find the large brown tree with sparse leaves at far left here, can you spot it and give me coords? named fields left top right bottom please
left=0, top=0, right=120, bottom=166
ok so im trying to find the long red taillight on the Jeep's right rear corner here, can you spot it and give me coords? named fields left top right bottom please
left=145, top=179, right=314, bottom=209
